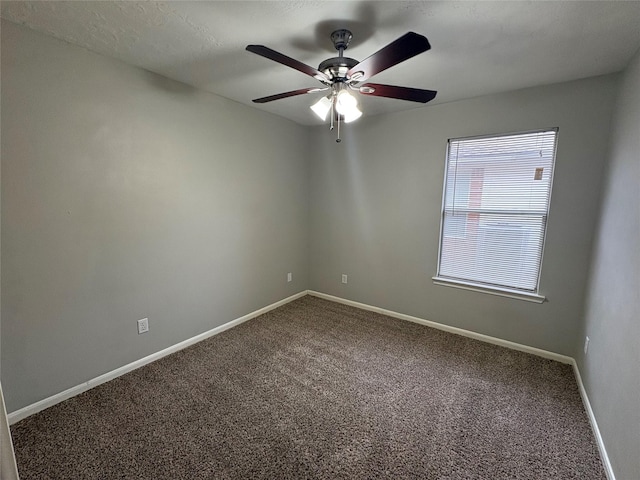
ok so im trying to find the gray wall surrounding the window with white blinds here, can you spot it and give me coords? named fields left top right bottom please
left=310, top=76, right=617, bottom=356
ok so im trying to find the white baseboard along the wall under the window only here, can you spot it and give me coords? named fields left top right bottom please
left=309, top=290, right=574, bottom=365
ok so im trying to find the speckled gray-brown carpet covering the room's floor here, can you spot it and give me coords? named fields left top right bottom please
left=12, top=296, right=605, bottom=480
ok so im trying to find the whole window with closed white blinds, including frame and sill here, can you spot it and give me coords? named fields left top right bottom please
left=434, top=129, right=557, bottom=301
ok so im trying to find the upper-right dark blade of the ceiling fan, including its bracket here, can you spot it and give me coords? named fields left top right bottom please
left=347, top=32, right=431, bottom=82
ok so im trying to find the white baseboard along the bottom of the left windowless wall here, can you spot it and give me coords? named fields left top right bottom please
left=8, top=290, right=307, bottom=425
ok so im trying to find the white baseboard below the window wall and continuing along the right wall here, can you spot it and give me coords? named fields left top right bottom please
left=308, top=290, right=616, bottom=480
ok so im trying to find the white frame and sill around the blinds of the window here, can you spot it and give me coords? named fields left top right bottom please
left=432, top=127, right=559, bottom=303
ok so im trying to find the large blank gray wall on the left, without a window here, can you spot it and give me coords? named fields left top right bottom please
left=1, top=22, right=309, bottom=412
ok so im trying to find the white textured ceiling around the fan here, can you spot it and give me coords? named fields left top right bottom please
left=1, top=0, right=640, bottom=125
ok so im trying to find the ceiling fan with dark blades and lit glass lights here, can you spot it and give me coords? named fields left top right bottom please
left=247, top=29, right=437, bottom=142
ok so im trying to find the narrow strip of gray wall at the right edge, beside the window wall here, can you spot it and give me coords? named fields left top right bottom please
left=575, top=47, right=640, bottom=479
